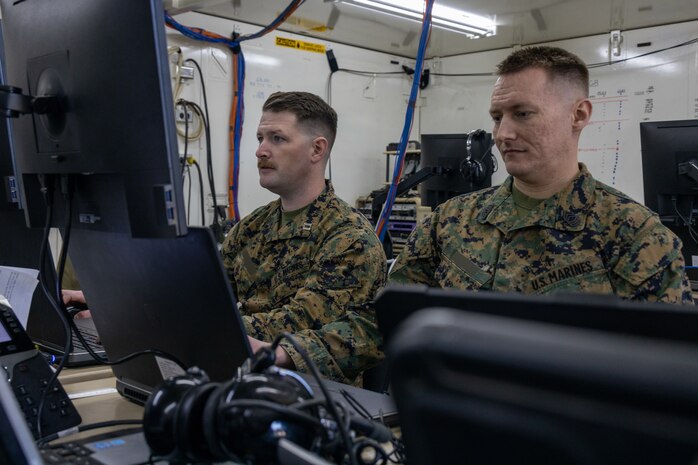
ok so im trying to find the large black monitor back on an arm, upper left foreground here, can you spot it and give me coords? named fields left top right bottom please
left=0, top=0, right=186, bottom=237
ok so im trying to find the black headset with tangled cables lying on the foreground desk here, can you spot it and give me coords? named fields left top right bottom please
left=143, top=339, right=393, bottom=464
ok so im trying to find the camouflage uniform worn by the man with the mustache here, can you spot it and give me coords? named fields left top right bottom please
left=222, top=182, right=386, bottom=384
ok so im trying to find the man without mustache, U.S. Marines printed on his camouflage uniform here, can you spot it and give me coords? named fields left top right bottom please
left=389, top=47, right=692, bottom=304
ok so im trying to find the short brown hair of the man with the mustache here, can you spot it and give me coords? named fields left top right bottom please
left=262, top=92, right=337, bottom=149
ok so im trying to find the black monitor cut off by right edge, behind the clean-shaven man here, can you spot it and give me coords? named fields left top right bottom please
left=640, top=119, right=698, bottom=281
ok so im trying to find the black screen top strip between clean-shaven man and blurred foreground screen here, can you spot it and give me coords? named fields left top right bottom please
left=376, top=285, right=698, bottom=344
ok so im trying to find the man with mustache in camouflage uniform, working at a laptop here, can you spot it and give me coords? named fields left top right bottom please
left=222, top=92, right=387, bottom=384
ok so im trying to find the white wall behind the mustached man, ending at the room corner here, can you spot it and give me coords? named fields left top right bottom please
left=167, top=13, right=419, bottom=224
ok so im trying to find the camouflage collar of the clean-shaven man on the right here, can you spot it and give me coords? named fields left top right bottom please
left=477, top=163, right=596, bottom=232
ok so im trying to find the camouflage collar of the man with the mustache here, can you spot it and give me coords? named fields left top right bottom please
left=264, top=180, right=334, bottom=241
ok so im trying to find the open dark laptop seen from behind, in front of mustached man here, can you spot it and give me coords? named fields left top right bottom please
left=70, top=227, right=397, bottom=423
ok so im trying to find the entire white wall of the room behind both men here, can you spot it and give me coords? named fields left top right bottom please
left=168, top=13, right=698, bottom=220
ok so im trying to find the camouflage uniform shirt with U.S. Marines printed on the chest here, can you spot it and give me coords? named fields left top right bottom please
left=389, top=164, right=692, bottom=303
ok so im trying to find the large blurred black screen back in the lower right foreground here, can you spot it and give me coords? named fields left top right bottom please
left=387, top=308, right=698, bottom=465
